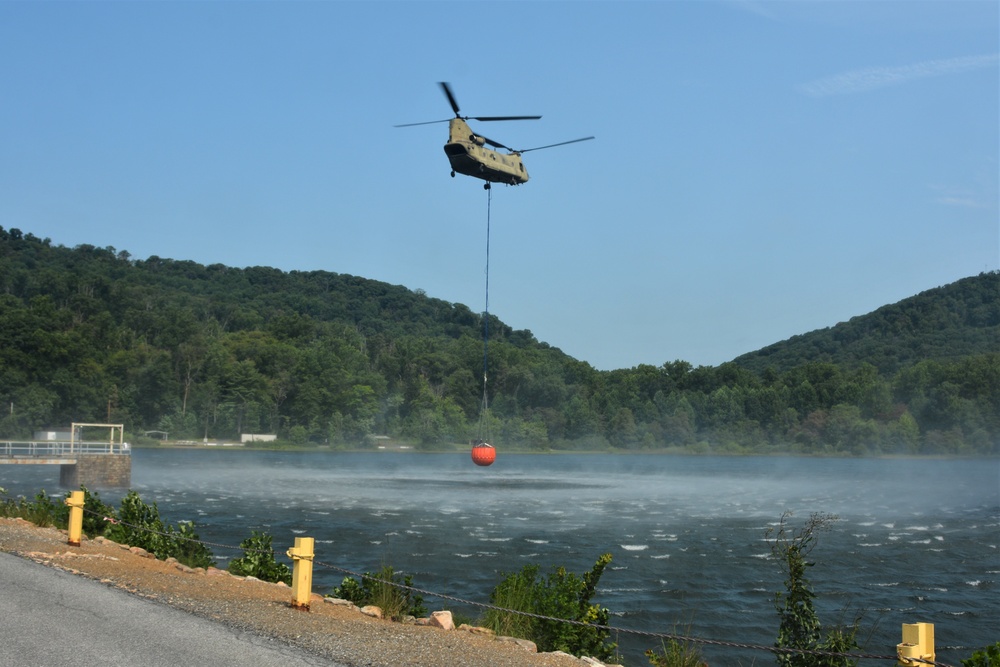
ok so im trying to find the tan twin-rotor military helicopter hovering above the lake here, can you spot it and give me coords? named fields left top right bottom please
left=396, top=81, right=594, bottom=190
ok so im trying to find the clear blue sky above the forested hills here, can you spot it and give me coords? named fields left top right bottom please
left=0, top=0, right=1000, bottom=369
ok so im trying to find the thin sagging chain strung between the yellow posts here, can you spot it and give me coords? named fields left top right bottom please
left=84, top=509, right=954, bottom=667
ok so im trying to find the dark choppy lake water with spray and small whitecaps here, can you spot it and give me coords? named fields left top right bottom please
left=0, top=449, right=1000, bottom=667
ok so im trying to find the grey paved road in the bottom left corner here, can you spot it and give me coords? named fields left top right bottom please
left=0, top=553, right=346, bottom=667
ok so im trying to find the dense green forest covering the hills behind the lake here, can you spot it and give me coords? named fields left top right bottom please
left=0, top=228, right=1000, bottom=454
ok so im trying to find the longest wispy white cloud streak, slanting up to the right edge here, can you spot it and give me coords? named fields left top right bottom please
left=799, top=54, right=1000, bottom=97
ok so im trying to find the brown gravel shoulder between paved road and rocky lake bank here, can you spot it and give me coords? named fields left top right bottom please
left=0, top=518, right=601, bottom=667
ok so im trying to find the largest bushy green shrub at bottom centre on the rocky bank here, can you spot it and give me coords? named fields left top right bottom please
left=483, top=554, right=617, bottom=661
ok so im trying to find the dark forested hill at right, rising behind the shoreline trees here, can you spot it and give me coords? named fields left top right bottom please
left=734, top=271, right=1000, bottom=374
